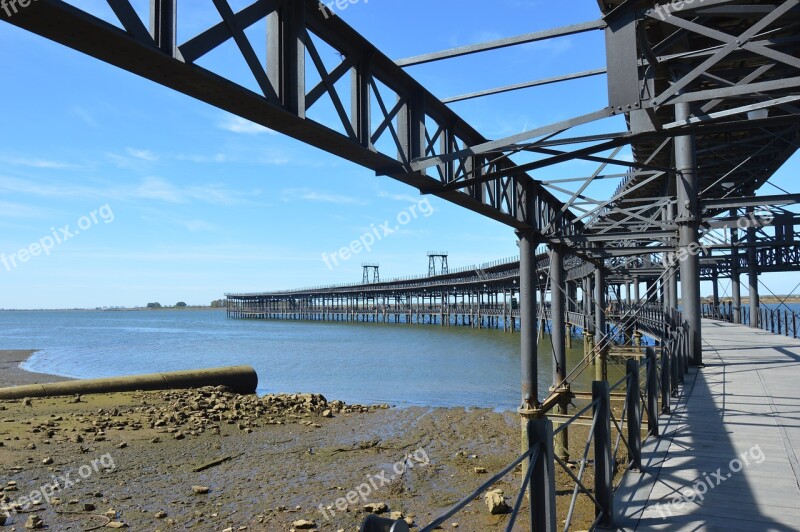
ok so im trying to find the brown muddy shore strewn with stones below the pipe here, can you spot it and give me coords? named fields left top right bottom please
left=0, top=352, right=593, bottom=532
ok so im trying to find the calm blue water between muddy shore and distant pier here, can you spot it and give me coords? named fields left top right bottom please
left=0, top=310, right=593, bottom=409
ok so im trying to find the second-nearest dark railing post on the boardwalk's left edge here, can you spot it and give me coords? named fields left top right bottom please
left=592, top=381, right=614, bottom=528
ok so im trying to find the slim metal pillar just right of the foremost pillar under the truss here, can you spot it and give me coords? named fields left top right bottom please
left=550, top=246, right=569, bottom=460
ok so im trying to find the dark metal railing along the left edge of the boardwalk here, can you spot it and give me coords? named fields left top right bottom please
left=362, top=326, right=689, bottom=532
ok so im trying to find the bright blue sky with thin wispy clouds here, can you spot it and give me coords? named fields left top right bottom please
left=0, top=0, right=798, bottom=308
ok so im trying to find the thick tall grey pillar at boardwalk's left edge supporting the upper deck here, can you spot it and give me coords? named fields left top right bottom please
left=675, top=103, right=703, bottom=366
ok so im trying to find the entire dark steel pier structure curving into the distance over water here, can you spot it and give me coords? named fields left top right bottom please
left=0, top=0, right=800, bottom=530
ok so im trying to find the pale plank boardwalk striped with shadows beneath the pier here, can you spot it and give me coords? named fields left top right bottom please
left=615, top=320, right=800, bottom=531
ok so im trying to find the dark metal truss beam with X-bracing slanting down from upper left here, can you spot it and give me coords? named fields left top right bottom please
left=0, top=0, right=598, bottom=234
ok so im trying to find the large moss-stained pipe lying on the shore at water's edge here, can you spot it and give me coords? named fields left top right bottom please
left=0, top=366, right=258, bottom=399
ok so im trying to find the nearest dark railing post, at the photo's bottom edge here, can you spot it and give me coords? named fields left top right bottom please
left=527, top=419, right=556, bottom=532
